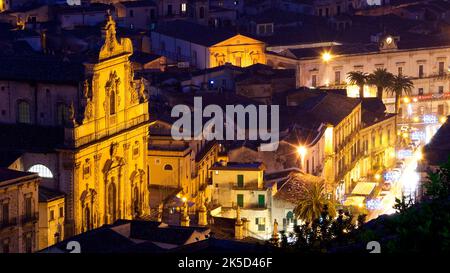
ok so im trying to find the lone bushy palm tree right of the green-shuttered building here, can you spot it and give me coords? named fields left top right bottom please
left=293, top=176, right=336, bottom=224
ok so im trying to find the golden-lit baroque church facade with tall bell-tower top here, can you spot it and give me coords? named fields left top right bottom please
left=64, top=16, right=149, bottom=233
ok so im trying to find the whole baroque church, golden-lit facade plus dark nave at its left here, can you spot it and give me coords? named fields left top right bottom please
left=0, top=15, right=150, bottom=238
